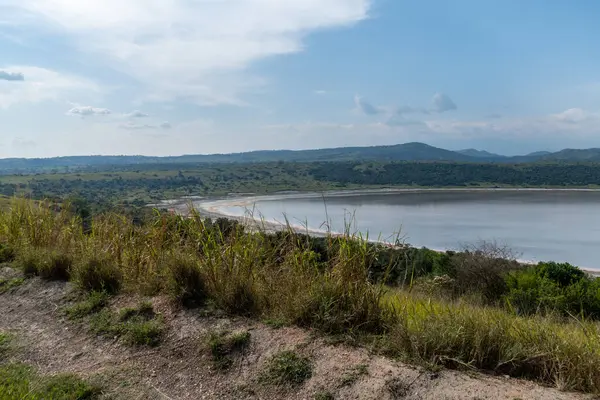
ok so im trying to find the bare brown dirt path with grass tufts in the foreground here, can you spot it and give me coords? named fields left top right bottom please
left=0, top=269, right=593, bottom=400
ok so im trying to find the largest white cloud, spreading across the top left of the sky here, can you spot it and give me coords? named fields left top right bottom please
left=2, top=0, right=372, bottom=104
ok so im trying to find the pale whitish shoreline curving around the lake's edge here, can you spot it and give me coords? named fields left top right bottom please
left=153, top=188, right=600, bottom=278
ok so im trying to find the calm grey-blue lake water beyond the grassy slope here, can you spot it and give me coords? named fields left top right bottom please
left=200, top=190, right=600, bottom=269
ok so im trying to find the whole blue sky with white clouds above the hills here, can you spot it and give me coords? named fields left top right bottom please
left=0, top=0, right=600, bottom=157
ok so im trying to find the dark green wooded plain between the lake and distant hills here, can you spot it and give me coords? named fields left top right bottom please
left=0, top=161, right=600, bottom=220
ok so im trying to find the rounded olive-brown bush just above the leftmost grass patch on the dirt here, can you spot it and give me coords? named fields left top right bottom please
left=74, top=257, right=122, bottom=293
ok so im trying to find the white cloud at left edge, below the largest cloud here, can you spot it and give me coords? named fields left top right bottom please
left=0, top=66, right=100, bottom=108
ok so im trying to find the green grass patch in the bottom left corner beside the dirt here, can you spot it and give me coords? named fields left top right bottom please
left=0, top=364, right=100, bottom=400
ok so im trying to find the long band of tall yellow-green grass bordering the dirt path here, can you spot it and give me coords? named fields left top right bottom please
left=0, top=199, right=600, bottom=392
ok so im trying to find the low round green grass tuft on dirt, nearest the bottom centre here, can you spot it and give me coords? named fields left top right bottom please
left=261, top=350, right=313, bottom=386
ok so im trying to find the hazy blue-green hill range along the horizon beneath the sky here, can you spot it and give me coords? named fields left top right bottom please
left=0, top=142, right=600, bottom=172
